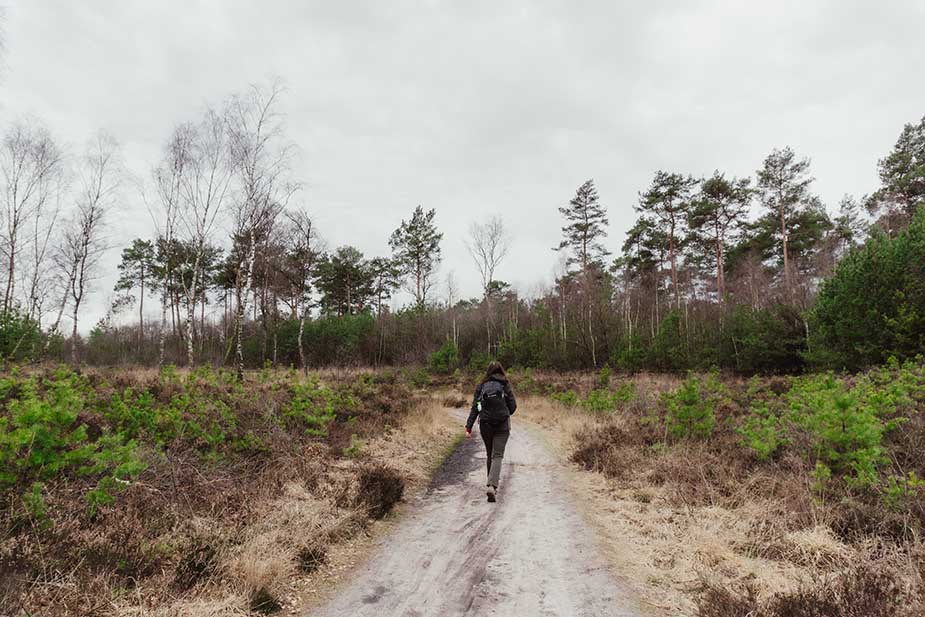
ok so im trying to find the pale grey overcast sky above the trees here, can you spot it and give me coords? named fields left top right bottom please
left=0, top=0, right=925, bottom=326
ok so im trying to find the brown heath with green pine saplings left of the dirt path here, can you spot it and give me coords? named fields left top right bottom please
left=0, top=368, right=456, bottom=615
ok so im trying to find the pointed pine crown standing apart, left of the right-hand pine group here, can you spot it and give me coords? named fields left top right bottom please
left=556, top=180, right=610, bottom=272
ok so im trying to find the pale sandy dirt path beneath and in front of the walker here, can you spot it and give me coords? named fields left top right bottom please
left=310, top=416, right=639, bottom=617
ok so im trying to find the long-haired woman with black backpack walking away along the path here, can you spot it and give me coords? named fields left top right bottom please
left=466, top=361, right=517, bottom=502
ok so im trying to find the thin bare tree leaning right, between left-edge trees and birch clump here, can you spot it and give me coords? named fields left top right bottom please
left=59, top=131, right=120, bottom=364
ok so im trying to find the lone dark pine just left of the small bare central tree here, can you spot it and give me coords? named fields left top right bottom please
left=389, top=205, right=443, bottom=308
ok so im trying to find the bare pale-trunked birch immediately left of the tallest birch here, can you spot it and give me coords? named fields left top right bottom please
left=177, top=109, right=232, bottom=366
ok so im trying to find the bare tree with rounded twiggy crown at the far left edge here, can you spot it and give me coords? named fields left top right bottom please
left=0, top=122, right=63, bottom=313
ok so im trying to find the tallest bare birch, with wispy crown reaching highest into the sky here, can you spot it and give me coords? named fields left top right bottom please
left=225, top=81, right=298, bottom=380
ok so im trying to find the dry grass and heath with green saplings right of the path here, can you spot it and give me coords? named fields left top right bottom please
left=498, top=361, right=925, bottom=617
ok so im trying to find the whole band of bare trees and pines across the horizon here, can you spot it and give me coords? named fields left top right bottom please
left=0, top=83, right=925, bottom=374
